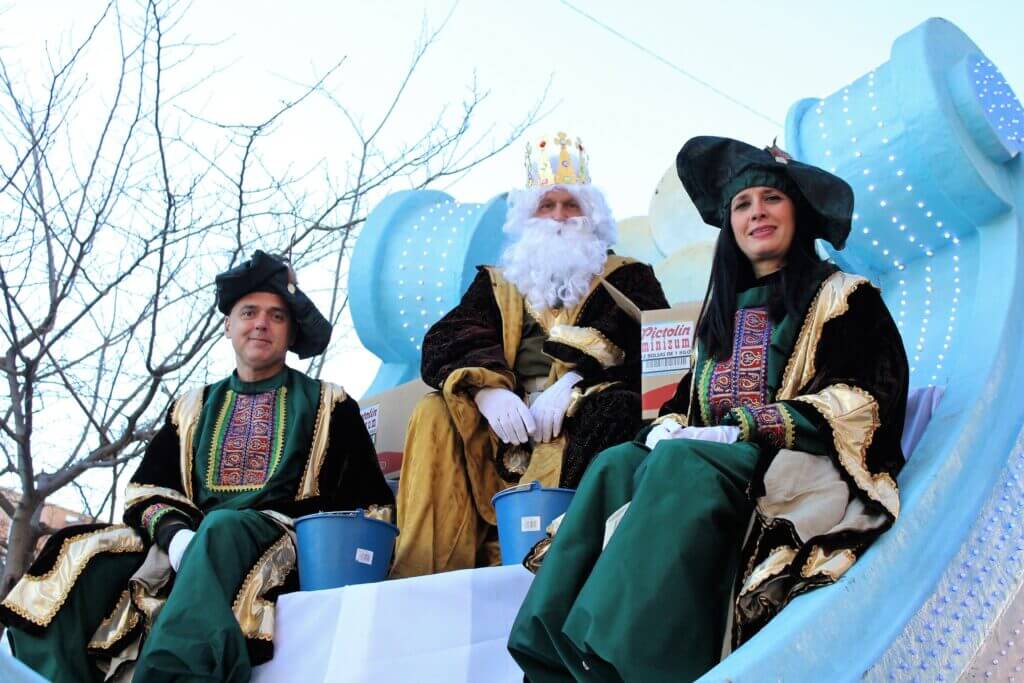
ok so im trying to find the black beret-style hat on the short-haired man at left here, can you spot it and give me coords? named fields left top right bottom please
left=216, top=249, right=332, bottom=358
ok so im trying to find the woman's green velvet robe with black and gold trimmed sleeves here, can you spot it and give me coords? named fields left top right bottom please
left=509, top=272, right=907, bottom=682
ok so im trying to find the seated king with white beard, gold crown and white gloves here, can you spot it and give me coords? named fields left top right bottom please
left=392, top=133, right=668, bottom=577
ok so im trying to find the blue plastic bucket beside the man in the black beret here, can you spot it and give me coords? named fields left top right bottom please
left=295, top=509, right=398, bottom=591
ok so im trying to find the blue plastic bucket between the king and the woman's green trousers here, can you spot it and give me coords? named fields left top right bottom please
left=490, top=481, right=575, bottom=564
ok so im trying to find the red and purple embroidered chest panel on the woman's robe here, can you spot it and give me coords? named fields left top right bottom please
left=700, top=307, right=771, bottom=425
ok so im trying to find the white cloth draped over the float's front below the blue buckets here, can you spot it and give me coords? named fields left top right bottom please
left=253, top=565, right=534, bottom=683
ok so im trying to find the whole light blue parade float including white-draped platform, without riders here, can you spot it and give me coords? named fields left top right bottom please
left=4, top=15, right=1024, bottom=682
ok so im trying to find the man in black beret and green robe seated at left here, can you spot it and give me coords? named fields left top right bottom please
left=0, top=251, right=394, bottom=682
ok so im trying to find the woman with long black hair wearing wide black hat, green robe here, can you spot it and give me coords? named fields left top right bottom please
left=509, top=137, right=908, bottom=682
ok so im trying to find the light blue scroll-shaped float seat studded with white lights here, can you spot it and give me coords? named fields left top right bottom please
left=349, top=14, right=1024, bottom=681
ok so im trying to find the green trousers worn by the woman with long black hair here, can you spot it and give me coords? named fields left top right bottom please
left=509, top=439, right=758, bottom=683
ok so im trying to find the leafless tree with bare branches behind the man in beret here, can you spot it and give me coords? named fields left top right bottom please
left=0, top=0, right=544, bottom=595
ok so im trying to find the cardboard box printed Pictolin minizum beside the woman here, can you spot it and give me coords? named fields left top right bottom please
left=640, top=301, right=700, bottom=420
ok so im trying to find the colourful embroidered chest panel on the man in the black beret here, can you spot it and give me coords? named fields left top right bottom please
left=206, top=387, right=288, bottom=492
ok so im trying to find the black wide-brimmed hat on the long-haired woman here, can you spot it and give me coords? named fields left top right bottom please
left=676, top=135, right=853, bottom=249
